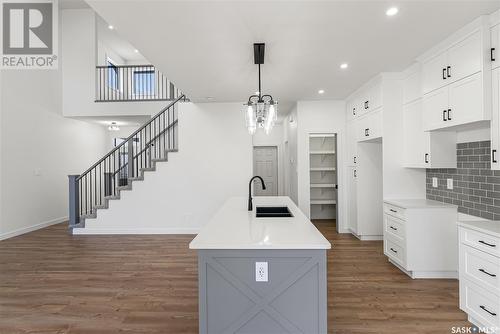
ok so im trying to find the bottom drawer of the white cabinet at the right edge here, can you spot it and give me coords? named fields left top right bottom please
left=460, top=279, right=500, bottom=327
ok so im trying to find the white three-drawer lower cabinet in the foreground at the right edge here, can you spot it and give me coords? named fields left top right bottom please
left=458, top=221, right=500, bottom=333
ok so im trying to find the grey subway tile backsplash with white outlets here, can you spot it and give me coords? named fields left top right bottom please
left=426, top=141, right=500, bottom=220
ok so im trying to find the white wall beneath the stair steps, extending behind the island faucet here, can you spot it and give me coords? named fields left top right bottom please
left=74, top=103, right=252, bottom=234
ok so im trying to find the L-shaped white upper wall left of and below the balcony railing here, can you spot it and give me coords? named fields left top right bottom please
left=59, top=9, right=168, bottom=116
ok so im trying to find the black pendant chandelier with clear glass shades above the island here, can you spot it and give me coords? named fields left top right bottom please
left=244, top=43, right=278, bottom=135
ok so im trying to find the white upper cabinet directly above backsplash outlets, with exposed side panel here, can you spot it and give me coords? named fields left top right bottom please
left=403, top=99, right=457, bottom=168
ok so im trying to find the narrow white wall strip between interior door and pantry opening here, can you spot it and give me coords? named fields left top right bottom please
left=283, top=104, right=299, bottom=205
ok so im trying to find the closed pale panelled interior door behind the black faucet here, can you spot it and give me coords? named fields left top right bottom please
left=253, top=146, right=278, bottom=196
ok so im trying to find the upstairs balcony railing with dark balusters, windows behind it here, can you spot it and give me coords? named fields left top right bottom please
left=95, top=65, right=183, bottom=102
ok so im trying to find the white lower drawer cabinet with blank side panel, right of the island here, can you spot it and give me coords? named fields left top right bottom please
left=384, top=199, right=458, bottom=278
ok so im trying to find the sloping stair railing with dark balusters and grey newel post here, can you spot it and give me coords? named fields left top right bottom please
left=68, top=95, right=186, bottom=230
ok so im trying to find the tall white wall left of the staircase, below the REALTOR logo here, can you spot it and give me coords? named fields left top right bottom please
left=0, top=70, right=107, bottom=239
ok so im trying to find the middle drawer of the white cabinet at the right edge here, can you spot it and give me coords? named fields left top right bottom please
left=460, top=244, right=500, bottom=296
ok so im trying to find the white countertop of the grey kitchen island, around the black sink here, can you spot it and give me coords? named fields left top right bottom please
left=189, top=196, right=331, bottom=249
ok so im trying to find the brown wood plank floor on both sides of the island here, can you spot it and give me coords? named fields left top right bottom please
left=0, top=221, right=468, bottom=334
